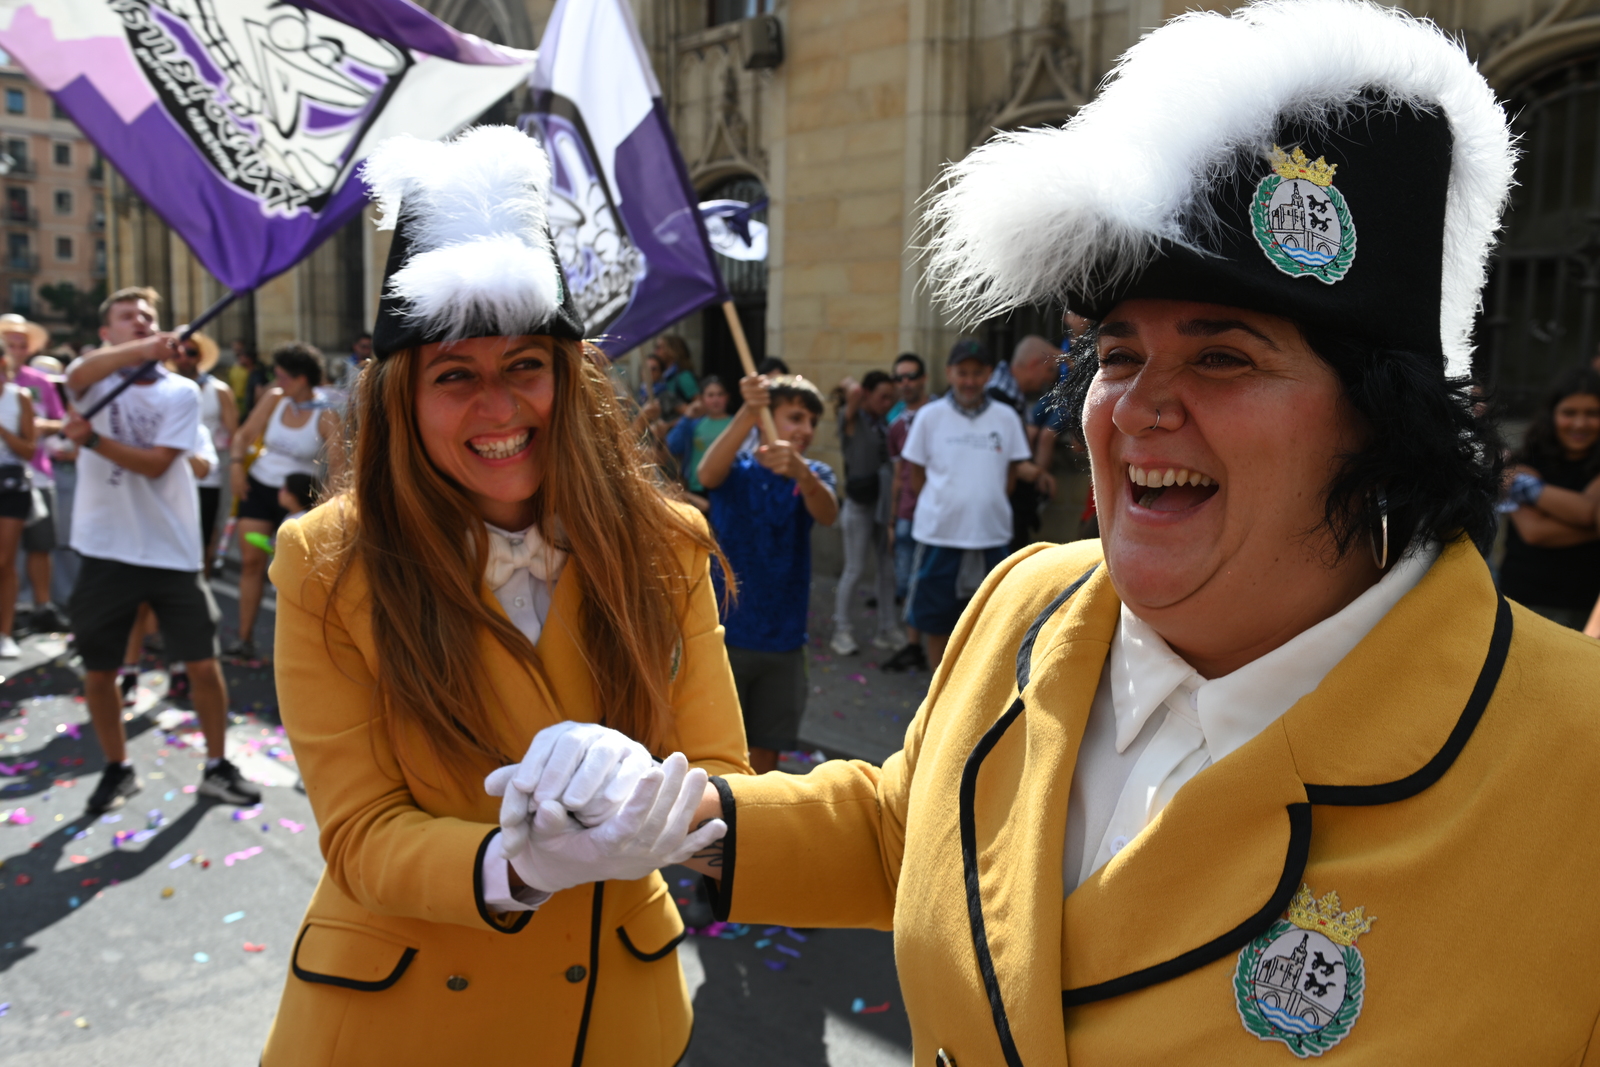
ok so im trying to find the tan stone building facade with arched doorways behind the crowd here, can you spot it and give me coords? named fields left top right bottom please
left=112, top=0, right=1600, bottom=435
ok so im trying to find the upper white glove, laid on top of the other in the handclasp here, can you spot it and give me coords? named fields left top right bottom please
left=483, top=721, right=656, bottom=856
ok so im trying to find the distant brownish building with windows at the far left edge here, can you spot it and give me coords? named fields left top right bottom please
left=0, top=54, right=107, bottom=341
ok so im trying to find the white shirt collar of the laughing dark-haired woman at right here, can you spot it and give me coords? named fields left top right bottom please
left=1110, top=544, right=1440, bottom=763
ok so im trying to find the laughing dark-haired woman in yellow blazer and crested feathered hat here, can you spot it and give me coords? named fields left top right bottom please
left=531, top=0, right=1600, bottom=1067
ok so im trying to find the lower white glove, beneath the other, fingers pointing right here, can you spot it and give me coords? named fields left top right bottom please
left=501, top=752, right=728, bottom=893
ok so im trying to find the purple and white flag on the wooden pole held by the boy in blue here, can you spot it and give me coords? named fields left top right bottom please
left=523, top=0, right=728, bottom=355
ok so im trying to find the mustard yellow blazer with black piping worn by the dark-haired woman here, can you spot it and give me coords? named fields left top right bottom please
left=718, top=542, right=1600, bottom=1067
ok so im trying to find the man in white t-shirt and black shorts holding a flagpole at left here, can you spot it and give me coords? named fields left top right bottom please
left=62, top=288, right=261, bottom=814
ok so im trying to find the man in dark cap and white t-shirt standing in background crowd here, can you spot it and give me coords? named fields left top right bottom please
left=901, top=339, right=1032, bottom=667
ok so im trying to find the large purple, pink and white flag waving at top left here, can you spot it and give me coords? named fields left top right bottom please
left=0, top=0, right=534, bottom=291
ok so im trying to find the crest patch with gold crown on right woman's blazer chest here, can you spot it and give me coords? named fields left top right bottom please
left=1234, top=885, right=1376, bottom=1059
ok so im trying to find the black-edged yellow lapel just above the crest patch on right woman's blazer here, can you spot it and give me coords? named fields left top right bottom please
left=1053, top=542, right=1510, bottom=1008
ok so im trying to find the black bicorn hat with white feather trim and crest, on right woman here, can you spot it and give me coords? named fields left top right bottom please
left=928, top=0, right=1515, bottom=378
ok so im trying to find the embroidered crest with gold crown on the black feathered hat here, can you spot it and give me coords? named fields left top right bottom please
left=1250, top=144, right=1355, bottom=285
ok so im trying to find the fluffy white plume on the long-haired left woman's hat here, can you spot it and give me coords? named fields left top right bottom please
left=362, top=126, right=562, bottom=341
